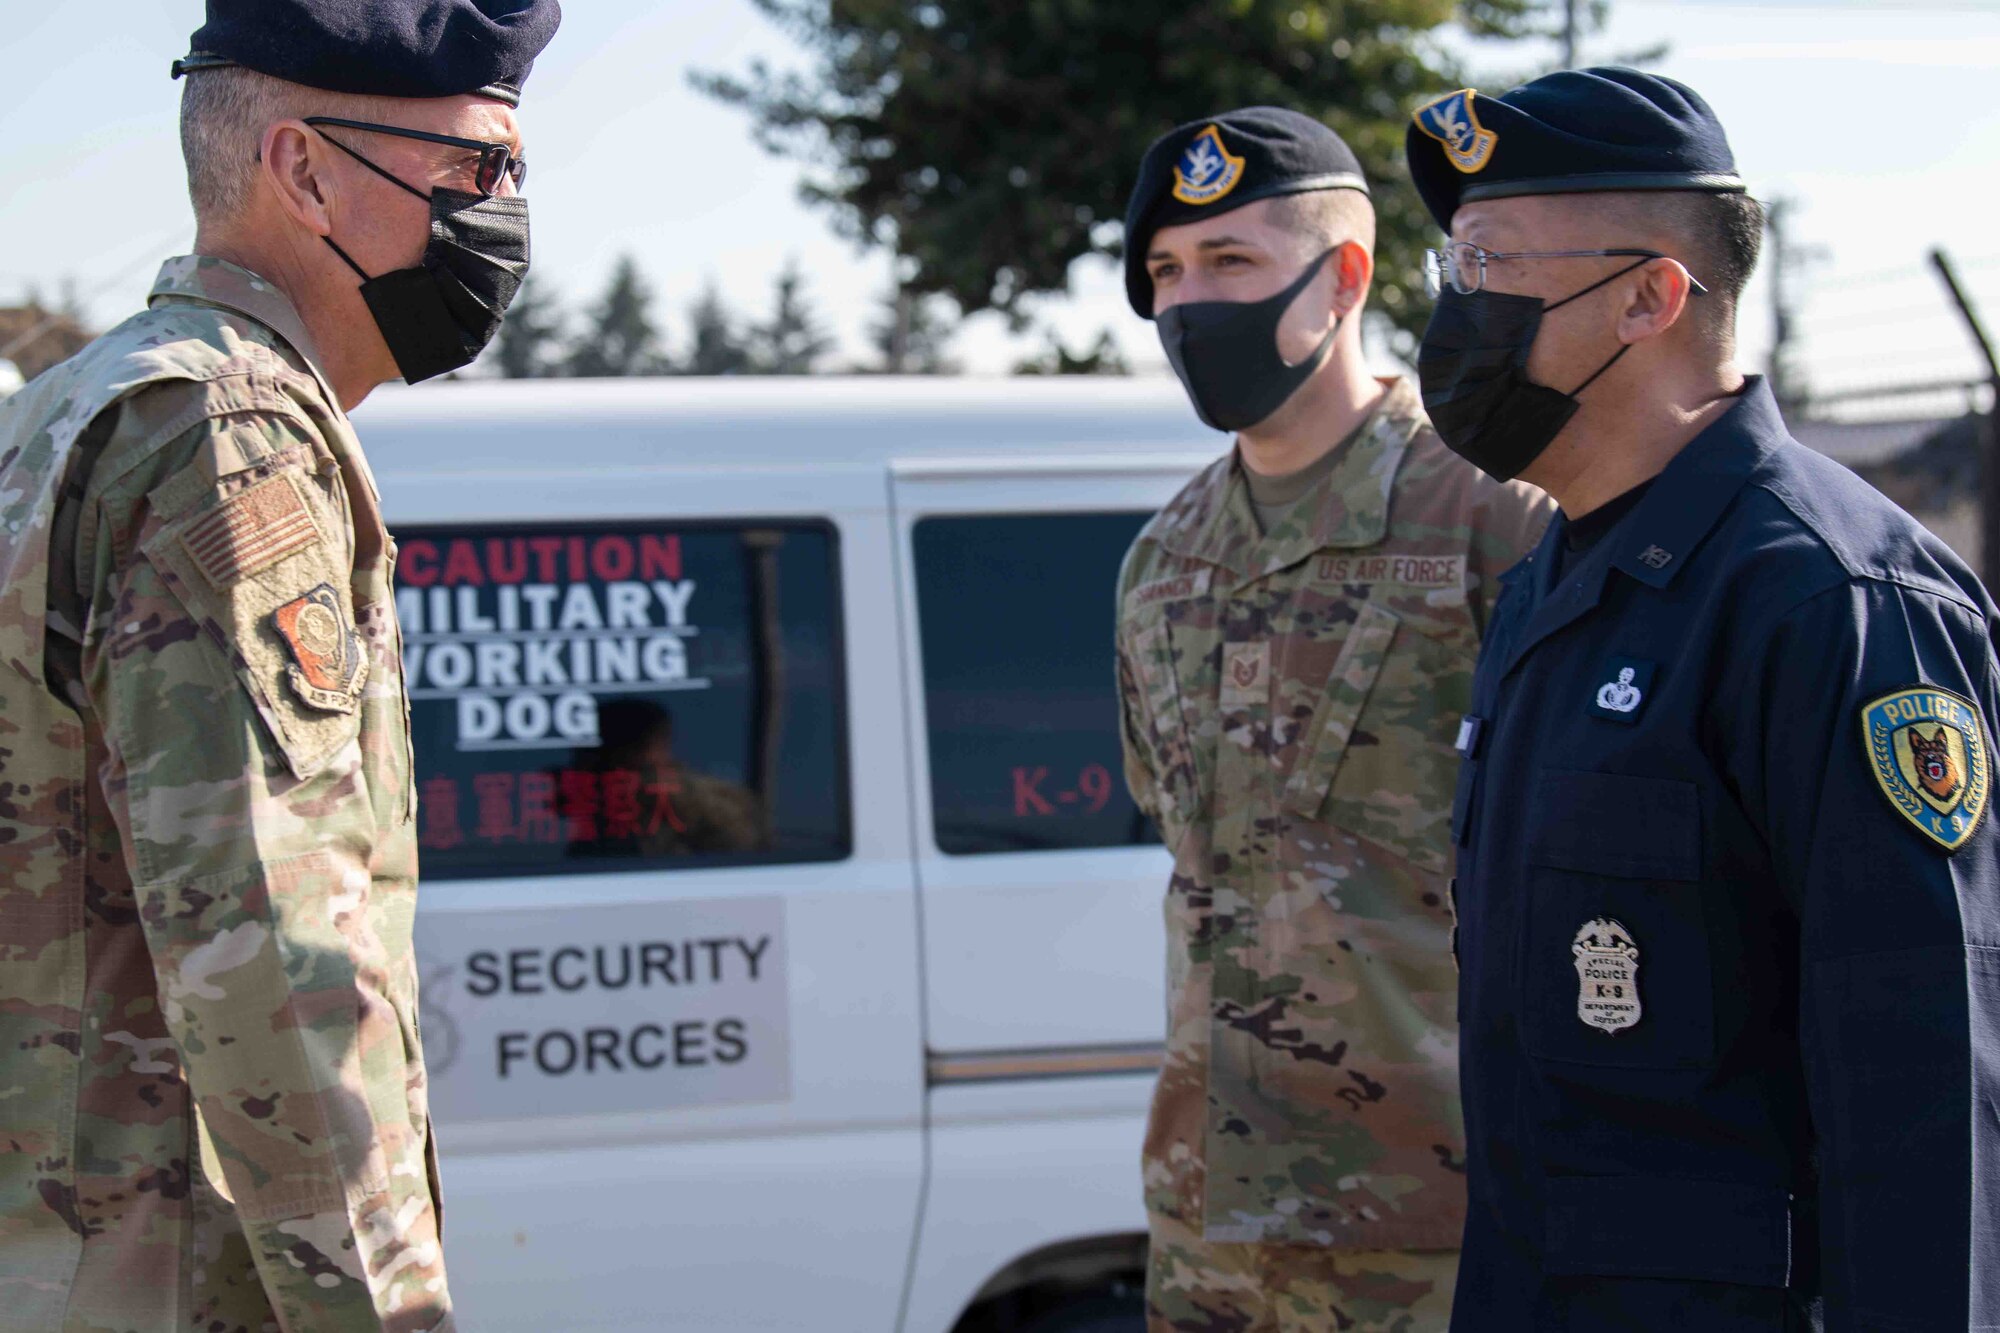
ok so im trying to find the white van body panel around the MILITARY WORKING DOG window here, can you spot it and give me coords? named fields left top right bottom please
left=372, top=460, right=924, bottom=1333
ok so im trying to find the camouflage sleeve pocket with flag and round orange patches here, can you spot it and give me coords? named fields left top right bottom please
left=140, top=466, right=368, bottom=779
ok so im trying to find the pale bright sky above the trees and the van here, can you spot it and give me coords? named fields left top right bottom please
left=0, top=0, right=2000, bottom=400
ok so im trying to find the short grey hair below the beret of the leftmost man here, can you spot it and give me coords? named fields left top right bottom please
left=180, top=68, right=390, bottom=224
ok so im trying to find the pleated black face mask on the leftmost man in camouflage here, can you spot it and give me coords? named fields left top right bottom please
left=326, top=140, right=528, bottom=384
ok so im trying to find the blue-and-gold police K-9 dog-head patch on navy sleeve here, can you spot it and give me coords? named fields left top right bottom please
left=1862, top=687, right=1992, bottom=853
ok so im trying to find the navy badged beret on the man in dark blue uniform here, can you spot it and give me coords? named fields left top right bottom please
left=1404, top=66, right=1744, bottom=230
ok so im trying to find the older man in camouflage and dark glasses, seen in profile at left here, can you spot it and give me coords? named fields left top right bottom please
left=0, top=0, right=558, bottom=1333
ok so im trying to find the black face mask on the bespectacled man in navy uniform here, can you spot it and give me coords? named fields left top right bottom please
left=1416, top=260, right=1652, bottom=480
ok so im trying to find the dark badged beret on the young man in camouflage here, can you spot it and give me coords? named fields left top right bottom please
left=1126, top=106, right=1368, bottom=320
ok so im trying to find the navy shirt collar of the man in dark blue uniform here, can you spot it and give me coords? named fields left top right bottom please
left=1600, top=374, right=1786, bottom=588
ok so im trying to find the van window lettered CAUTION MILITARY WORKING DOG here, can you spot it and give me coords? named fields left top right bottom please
left=396, top=522, right=848, bottom=879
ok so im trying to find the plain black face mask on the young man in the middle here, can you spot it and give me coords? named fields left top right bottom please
left=1156, top=250, right=1340, bottom=430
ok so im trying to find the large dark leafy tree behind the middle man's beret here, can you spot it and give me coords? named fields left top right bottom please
left=694, top=0, right=1602, bottom=342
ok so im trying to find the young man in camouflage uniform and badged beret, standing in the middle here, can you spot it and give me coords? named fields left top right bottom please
left=1118, top=108, right=1550, bottom=1333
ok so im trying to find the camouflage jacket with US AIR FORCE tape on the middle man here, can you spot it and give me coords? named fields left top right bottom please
left=1118, top=380, right=1550, bottom=1249
